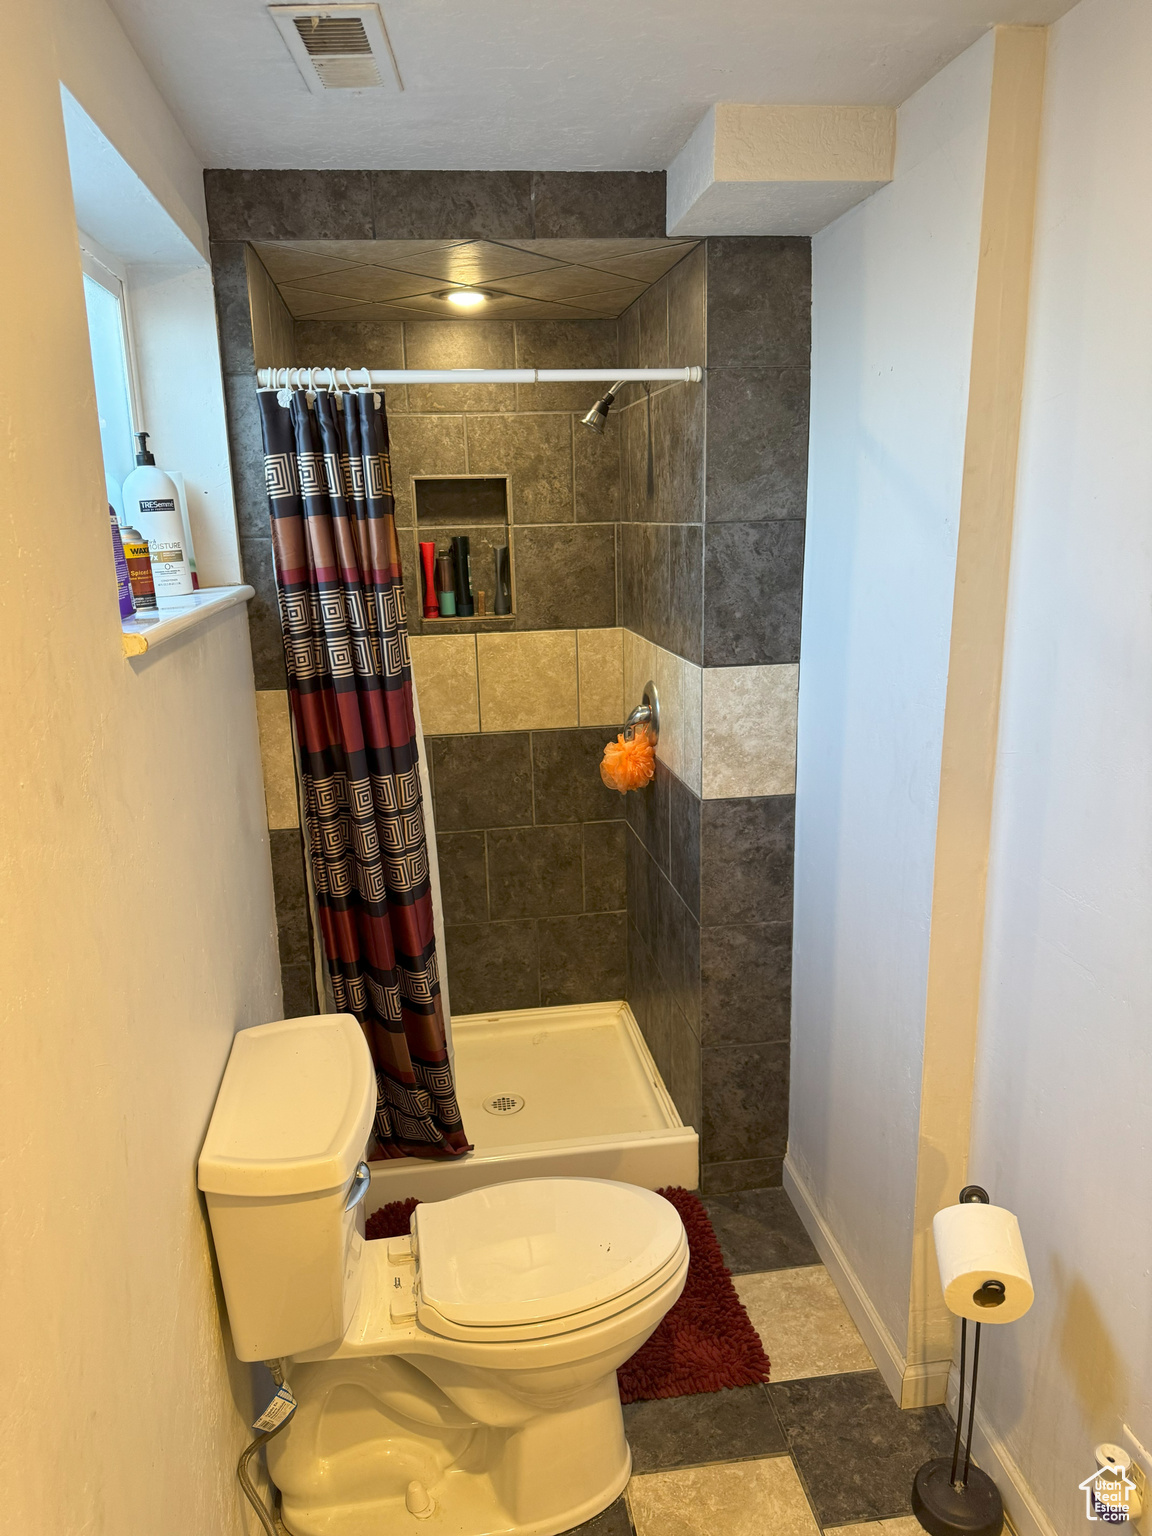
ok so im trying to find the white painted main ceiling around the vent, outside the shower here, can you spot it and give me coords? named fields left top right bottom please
left=103, top=0, right=1072, bottom=170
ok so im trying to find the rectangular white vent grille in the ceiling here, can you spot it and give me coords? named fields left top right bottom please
left=269, top=5, right=404, bottom=95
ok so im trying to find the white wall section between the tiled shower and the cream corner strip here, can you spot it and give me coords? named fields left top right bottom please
left=790, top=35, right=992, bottom=1349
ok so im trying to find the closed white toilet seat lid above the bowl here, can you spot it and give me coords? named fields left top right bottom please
left=413, top=1178, right=687, bottom=1341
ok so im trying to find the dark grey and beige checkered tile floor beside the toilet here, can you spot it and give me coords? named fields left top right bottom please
left=573, top=1189, right=952, bottom=1536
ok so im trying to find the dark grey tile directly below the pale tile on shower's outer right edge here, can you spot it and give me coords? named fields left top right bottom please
left=700, top=794, right=796, bottom=928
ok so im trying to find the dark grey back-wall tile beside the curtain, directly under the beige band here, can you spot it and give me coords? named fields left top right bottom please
left=429, top=731, right=531, bottom=833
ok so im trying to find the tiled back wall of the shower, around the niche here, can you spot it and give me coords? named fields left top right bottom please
left=295, top=311, right=625, bottom=1014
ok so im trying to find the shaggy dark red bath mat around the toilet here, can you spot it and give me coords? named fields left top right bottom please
left=366, top=1189, right=768, bottom=1402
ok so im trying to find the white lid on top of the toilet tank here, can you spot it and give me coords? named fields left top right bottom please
left=200, top=1014, right=376, bottom=1197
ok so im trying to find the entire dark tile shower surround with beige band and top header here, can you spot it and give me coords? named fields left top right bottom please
left=207, top=172, right=809, bottom=1190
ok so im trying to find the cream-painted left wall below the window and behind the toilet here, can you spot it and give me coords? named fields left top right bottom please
left=0, top=6, right=280, bottom=1536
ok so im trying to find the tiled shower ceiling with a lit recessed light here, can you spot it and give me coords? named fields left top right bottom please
left=255, top=240, right=696, bottom=319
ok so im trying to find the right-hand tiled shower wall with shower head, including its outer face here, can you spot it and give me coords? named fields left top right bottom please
left=621, top=238, right=811, bottom=1192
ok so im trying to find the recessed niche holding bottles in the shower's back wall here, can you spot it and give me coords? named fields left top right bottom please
left=413, top=475, right=516, bottom=633
